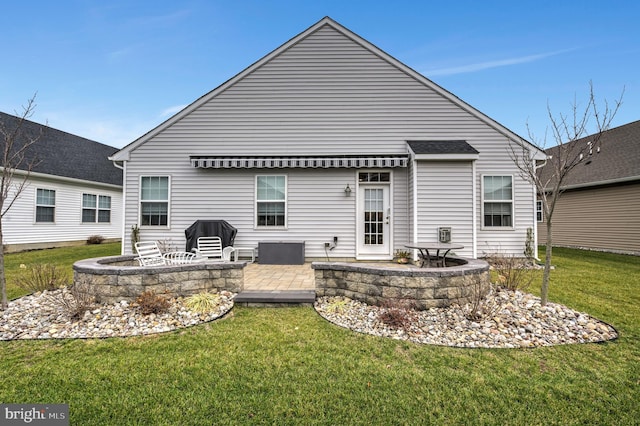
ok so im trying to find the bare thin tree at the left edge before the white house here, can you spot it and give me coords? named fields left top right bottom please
left=0, top=95, right=43, bottom=310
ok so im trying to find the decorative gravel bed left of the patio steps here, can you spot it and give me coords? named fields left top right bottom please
left=0, top=288, right=235, bottom=340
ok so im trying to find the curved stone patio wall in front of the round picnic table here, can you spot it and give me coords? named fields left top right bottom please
left=311, top=259, right=490, bottom=309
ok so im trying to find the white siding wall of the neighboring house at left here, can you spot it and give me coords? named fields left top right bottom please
left=2, top=177, right=122, bottom=245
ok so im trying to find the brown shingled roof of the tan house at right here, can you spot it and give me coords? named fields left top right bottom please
left=541, top=120, right=640, bottom=189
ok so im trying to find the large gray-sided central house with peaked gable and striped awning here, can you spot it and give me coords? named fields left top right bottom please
left=112, top=18, right=544, bottom=260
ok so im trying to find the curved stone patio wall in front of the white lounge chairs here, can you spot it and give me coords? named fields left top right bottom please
left=73, top=256, right=246, bottom=303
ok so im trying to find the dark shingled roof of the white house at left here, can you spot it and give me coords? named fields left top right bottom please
left=0, top=112, right=122, bottom=186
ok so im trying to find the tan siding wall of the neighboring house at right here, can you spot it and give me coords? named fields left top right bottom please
left=538, top=183, right=640, bottom=253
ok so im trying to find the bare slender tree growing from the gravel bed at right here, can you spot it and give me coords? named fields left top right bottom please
left=510, top=82, right=624, bottom=306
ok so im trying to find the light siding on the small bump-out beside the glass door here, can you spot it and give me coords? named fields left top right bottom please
left=417, top=161, right=473, bottom=257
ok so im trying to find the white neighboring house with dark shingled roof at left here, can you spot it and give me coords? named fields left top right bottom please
left=0, top=113, right=122, bottom=251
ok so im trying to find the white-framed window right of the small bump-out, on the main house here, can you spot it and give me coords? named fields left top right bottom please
left=482, top=176, right=513, bottom=227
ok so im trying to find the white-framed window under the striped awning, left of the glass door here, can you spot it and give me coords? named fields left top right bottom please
left=256, top=175, right=287, bottom=227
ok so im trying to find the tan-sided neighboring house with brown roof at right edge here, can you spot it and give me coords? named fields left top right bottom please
left=538, top=121, right=640, bottom=254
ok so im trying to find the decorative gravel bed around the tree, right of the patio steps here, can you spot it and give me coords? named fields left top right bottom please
left=315, top=290, right=618, bottom=348
